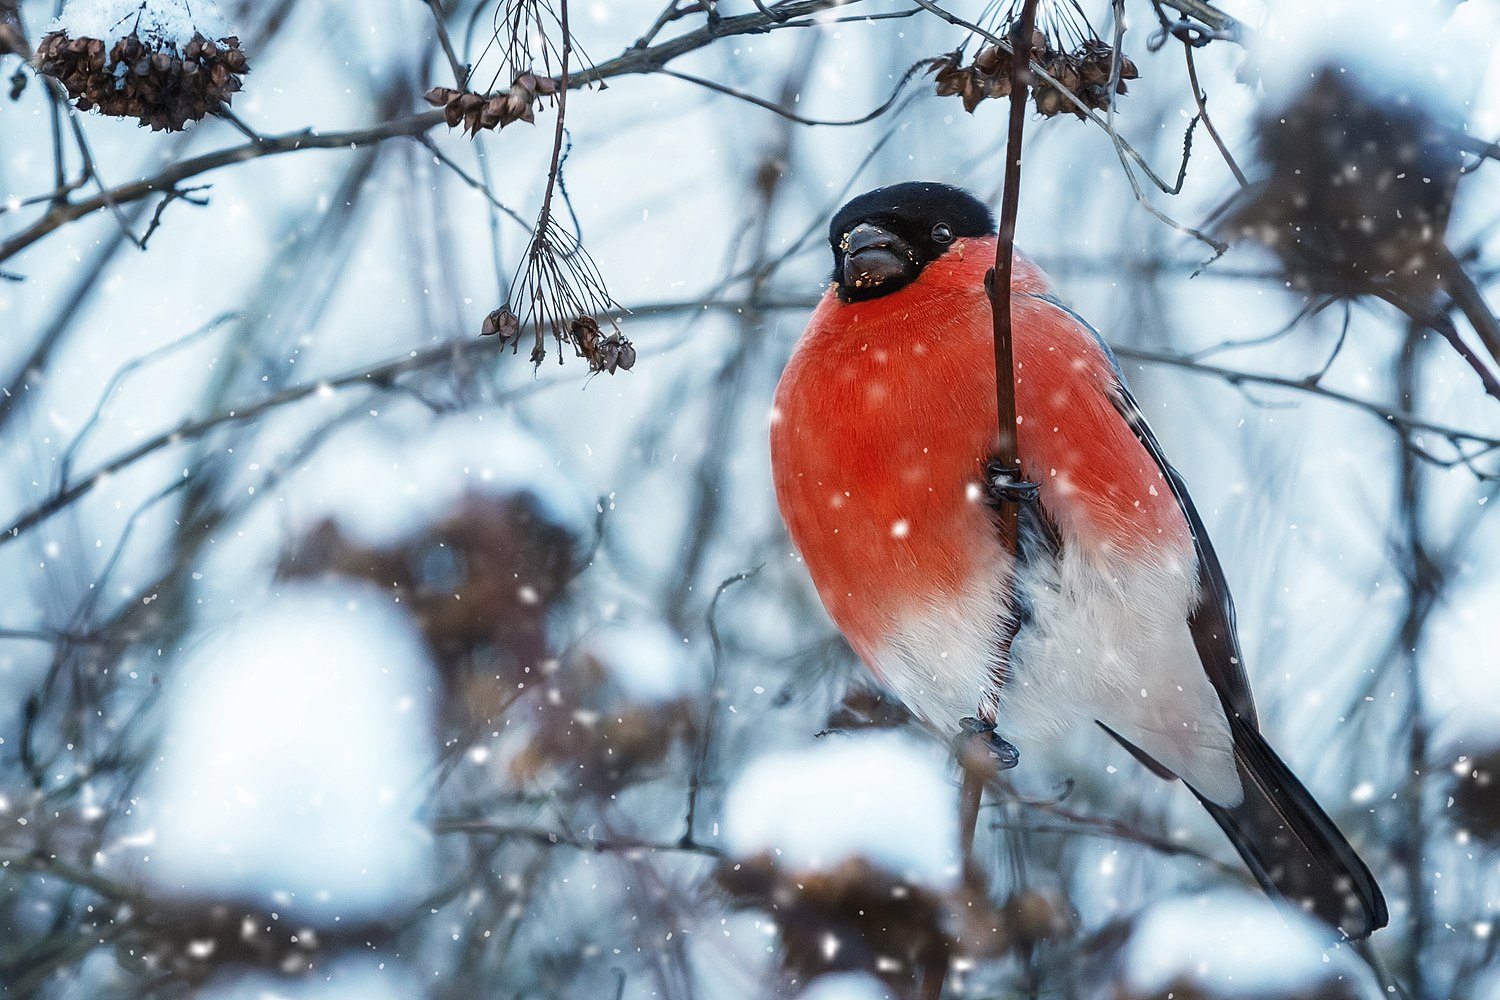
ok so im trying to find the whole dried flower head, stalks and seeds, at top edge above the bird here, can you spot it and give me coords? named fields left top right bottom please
left=927, top=0, right=1140, bottom=118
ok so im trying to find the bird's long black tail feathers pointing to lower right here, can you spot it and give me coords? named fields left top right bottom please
left=1190, top=717, right=1389, bottom=939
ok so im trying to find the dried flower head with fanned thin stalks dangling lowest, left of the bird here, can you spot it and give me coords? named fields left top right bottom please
left=480, top=210, right=636, bottom=375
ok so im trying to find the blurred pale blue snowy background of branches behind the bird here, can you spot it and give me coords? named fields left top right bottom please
left=0, top=0, right=1500, bottom=1000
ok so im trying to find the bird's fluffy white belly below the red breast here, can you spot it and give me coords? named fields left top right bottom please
left=873, top=536, right=1241, bottom=805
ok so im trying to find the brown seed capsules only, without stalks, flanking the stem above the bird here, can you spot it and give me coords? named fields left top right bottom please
left=927, top=31, right=1140, bottom=118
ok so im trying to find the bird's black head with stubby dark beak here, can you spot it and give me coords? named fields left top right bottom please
left=828, top=181, right=995, bottom=301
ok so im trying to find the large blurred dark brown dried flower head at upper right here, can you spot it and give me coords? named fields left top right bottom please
left=1223, top=67, right=1464, bottom=295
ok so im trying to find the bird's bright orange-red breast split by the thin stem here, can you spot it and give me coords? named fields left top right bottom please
left=771, top=237, right=1193, bottom=663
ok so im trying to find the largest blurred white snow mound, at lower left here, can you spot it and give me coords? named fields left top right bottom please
left=143, top=585, right=432, bottom=919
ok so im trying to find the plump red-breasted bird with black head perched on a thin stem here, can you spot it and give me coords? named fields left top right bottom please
left=771, top=183, right=1388, bottom=937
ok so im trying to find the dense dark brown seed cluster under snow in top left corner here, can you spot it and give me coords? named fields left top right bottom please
left=36, top=31, right=249, bottom=132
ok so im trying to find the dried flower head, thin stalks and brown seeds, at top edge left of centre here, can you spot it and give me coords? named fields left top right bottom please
left=425, top=0, right=603, bottom=135
